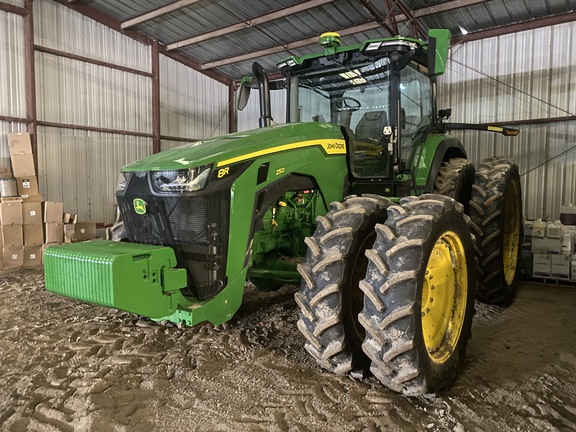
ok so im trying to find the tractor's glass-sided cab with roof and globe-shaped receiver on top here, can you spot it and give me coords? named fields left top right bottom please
left=278, top=31, right=450, bottom=196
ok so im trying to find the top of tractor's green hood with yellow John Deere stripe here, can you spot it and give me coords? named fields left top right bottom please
left=122, top=122, right=344, bottom=172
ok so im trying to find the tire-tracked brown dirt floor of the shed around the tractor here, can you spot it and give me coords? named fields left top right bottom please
left=0, top=269, right=576, bottom=432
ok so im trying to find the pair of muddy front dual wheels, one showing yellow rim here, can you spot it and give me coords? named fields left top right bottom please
left=295, top=195, right=476, bottom=395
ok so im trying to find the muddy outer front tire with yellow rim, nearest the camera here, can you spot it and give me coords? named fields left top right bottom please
left=359, top=194, right=476, bottom=396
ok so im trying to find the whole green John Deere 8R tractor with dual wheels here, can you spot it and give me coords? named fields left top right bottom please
left=44, top=30, right=522, bottom=395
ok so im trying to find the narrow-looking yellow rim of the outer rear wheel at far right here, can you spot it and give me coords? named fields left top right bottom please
left=502, top=182, right=521, bottom=285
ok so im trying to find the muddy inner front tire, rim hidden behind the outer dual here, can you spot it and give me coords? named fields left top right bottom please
left=295, top=195, right=391, bottom=374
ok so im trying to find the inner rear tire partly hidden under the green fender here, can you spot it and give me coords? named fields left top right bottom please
left=434, top=158, right=476, bottom=214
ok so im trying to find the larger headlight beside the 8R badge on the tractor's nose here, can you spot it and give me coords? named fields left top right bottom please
left=152, top=165, right=211, bottom=192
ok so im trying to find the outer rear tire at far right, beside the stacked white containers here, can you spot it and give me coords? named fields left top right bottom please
left=470, top=157, right=523, bottom=306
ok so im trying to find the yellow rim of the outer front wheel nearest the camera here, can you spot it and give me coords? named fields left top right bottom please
left=422, top=231, right=468, bottom=363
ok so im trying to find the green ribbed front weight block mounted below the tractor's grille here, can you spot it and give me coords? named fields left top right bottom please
left=44, top=240, right=186, bottom=318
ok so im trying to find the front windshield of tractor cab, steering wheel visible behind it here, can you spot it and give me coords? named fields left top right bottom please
left=289, top=57, right=390, bottom=177
